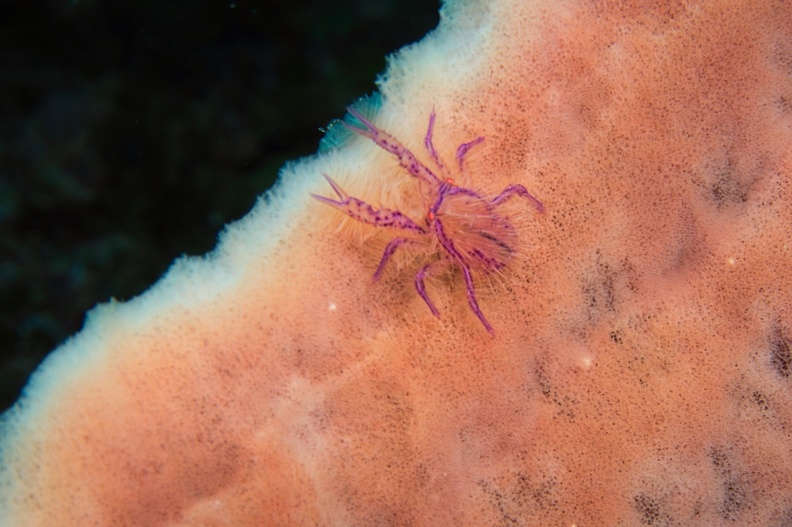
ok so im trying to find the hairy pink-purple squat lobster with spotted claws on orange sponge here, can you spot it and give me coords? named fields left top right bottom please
left=312, top=108, right=544, bottom=335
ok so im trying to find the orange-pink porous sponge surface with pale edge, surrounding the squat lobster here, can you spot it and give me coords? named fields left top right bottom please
left=0, top=0, right=792, bottom=526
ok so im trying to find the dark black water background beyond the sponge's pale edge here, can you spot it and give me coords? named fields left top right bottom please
left=0, top=0, right=438, bottom=411
